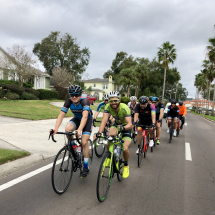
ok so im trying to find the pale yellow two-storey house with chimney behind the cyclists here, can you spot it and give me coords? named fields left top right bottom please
left=83, top=75, right=127, bottom=100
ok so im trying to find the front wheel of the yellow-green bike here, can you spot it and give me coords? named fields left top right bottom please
left=96, top=153, right=113, bottom=202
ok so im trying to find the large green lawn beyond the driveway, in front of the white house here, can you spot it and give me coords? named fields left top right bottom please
left=0, top=100, right=98, bottom=120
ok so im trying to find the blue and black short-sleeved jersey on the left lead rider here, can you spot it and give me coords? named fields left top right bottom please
left=61, top=98, right=93, bottom=120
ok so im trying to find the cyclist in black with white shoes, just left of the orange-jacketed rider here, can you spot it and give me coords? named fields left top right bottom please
left=167, top=99, right=179, bottom=137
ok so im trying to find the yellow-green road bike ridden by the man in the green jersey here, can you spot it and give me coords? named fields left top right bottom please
left=96, top=134, right=124, bottom=202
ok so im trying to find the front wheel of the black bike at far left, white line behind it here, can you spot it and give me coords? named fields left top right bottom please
left=51, top=147, right=74, bottom=194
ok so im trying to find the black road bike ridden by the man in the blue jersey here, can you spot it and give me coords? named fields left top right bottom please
left=49, top=129, right=93, bottom=194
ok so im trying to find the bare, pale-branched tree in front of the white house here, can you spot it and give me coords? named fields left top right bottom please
left=1, top=44, right=38, bottom=87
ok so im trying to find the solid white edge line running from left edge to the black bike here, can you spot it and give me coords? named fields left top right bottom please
left=0, top=156, right=68, bottom=192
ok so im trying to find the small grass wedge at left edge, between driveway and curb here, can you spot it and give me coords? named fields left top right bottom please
left=0, top=149, right=30, bottom=165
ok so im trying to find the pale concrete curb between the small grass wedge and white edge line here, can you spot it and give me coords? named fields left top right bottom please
left=0, top=154, right=44, bottom=179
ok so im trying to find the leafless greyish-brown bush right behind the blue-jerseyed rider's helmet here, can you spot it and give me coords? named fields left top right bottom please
left=52, top=67, right=74, bottom=86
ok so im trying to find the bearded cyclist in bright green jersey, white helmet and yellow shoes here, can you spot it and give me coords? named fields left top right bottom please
left=97, top=91, right=132, bottom=178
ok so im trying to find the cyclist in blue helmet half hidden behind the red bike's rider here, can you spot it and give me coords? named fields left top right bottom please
left=152, top=97, right=164, bottom=145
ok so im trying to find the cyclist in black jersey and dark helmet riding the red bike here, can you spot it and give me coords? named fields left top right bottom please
left=134, top=96, right=155, bottom=154
